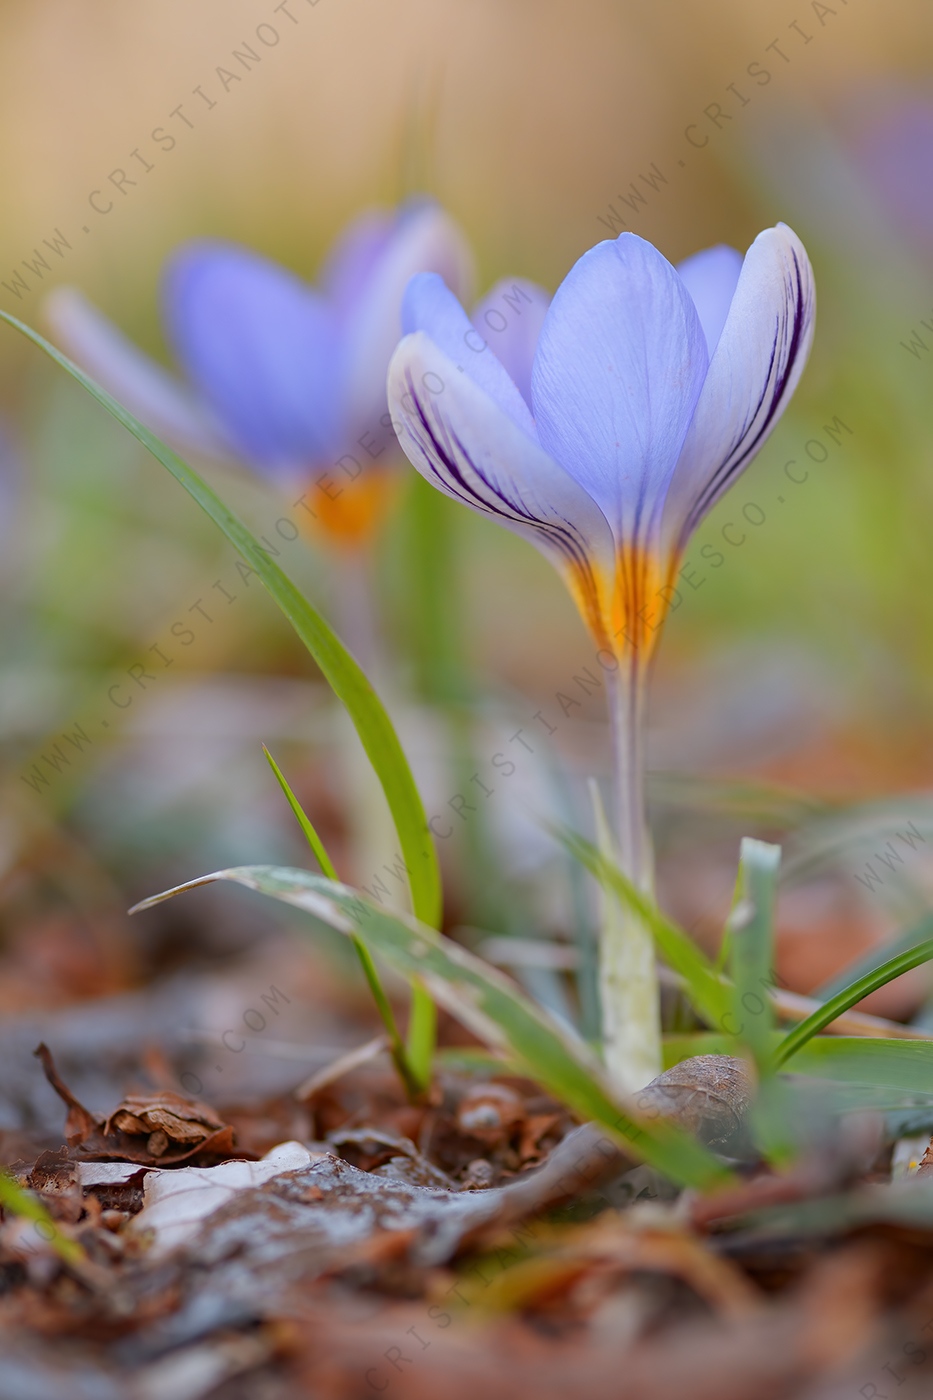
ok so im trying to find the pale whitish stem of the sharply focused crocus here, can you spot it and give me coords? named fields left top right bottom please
left=597, top=659, right=661, bottom=1093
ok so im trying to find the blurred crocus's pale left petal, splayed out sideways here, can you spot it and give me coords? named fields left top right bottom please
left=42, top=287, right=231, bottom=456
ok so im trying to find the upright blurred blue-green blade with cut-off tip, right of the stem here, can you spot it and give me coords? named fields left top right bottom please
left=727, top=837, right=780, bottom=1075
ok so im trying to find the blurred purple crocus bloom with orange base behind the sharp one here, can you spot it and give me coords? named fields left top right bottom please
left=46, top=200, right=471, bottom=545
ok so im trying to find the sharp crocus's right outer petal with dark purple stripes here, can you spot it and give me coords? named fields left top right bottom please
left=663, top=224, right=815, bottom=550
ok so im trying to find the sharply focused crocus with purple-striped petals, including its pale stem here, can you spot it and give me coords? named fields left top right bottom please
left=388, top=224, right=814, bottom=1089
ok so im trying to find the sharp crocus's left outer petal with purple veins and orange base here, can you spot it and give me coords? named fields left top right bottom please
left=388, top=330, right=615, bottom=631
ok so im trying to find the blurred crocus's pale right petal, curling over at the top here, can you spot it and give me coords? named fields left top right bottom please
left=337, top=200, right=472, bottom=441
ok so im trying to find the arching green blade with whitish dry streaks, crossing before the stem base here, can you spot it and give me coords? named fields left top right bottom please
left=136, top=865, right=728, bottom=1189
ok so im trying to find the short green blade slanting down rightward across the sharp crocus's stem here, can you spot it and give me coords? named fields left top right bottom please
left=551, top=827, right=731, bottom=1029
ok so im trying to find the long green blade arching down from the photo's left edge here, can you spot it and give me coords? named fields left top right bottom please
left=0, top=311, right=441, bottom=927
